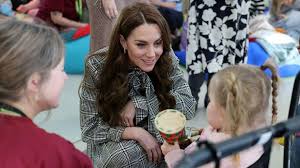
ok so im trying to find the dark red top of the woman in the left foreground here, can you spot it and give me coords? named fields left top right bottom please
left=0, top=114, right=92, bottom=168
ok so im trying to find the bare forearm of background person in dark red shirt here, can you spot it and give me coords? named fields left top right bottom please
left=50, top=11, right=87, bottom=28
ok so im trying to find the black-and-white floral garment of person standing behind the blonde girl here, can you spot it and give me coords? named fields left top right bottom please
left=187, top=0, right=264, bottom=74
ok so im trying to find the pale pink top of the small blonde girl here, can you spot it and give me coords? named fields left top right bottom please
left=165, top=126, right=264, bottom=168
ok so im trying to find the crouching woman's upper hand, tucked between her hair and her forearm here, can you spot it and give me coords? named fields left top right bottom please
left=121, top=100, right=135, bottom=127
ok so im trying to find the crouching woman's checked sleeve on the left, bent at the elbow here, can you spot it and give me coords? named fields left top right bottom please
left=79, top=50, right=125, bottom=144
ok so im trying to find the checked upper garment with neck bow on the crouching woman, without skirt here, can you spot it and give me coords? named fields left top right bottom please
left=79, top=48, right=196, bottom=166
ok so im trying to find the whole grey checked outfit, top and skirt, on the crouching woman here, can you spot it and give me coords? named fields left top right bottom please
left=79, top=48, right=195, bottom=168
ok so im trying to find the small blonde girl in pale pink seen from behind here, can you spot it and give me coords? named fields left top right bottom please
left=161, top=64, right=278, bottom=168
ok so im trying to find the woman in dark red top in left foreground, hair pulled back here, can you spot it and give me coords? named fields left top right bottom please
left=0, top=20, right=92, bottom=168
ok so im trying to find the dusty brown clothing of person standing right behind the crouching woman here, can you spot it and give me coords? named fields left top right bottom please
left=86, top=0, right=148, bottom=53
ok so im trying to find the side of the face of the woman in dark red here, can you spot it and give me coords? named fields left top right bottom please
left=38, top=59, right=67, bottom=110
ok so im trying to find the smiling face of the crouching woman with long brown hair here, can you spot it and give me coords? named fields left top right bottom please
left=120, top=23, right=163, bottom=72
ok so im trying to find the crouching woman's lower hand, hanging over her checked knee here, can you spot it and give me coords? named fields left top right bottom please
left=136, top=128, right=162, bottom=162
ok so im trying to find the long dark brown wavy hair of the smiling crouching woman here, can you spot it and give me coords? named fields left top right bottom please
left=97, top=3, right=176, bottom=126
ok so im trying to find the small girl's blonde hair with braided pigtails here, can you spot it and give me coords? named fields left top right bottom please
left=209, top=64, right=278, bottom=136
